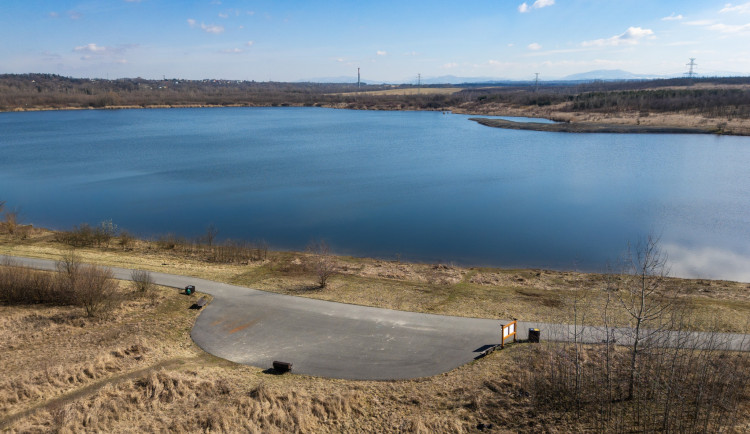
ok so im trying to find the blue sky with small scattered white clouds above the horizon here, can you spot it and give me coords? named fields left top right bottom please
left=0, top=0, right=750, bottom=82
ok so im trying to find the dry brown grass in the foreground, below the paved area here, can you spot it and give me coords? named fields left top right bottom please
left=0, top=284, right=572, bottom=432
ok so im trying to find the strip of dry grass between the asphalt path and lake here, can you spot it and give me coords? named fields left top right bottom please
left=0, top=232, right=750, bottom=332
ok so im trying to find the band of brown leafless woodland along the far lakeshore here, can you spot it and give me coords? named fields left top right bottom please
left=0, top=74, right=750, bottom=119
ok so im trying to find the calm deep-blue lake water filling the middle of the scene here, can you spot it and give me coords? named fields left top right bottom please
left=0, top=108, right=750, bottom=281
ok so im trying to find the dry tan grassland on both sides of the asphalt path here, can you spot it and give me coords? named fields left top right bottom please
left=0, top=229, right=750, bottom=433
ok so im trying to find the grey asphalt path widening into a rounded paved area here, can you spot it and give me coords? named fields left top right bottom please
left=5, top=256, right=750, bottom=380
